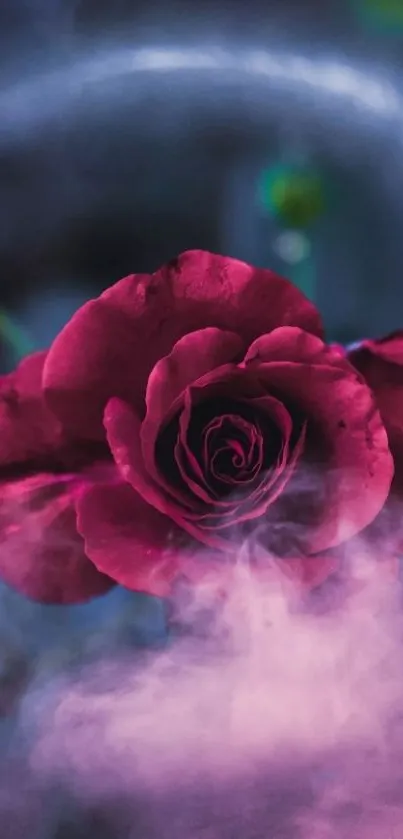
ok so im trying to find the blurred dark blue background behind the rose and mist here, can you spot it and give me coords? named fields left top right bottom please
left=0, top=0, right=403, bottom=839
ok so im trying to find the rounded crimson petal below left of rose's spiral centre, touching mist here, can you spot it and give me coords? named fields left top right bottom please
left=77, top=483, right=201, bottom=597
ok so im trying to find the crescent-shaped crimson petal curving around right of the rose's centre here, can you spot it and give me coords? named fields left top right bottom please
left=245, top=329, right=394, bottom=553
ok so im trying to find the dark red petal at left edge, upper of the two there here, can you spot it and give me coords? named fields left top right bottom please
left=0, top=352, right=65, bottom=466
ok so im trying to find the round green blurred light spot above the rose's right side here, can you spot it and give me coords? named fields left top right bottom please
left=260, top=165, right=326, bottom=230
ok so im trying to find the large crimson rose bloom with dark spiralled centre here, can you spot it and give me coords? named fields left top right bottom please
left=0, top=251, right=393, bottom=600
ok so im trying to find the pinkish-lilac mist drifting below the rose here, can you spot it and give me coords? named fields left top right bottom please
left=0, top=528, right=403, bottom=839
